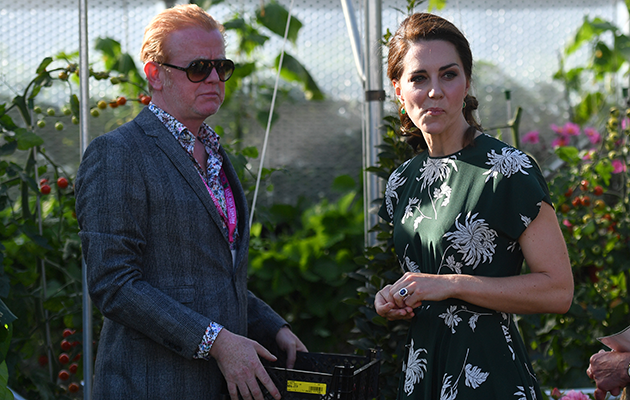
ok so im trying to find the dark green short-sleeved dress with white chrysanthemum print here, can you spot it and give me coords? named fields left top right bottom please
left=379, top=134, right=551, bottom=400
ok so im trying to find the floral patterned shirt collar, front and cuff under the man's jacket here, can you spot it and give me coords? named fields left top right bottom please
left=149, top=102, right=230, bottom=360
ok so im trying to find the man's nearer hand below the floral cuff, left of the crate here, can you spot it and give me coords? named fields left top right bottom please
left=210, top=328, right=280, bottom=400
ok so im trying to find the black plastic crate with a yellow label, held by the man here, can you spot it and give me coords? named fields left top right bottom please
left=263, top=350, right=380, bottom=400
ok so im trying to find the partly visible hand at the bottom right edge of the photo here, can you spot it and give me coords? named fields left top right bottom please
left=586, top=350, right=630, bottom=400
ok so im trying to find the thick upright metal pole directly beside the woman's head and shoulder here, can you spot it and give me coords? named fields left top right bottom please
left=364, top=0, right=385, bottom=247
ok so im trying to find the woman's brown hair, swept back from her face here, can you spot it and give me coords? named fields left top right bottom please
left=387, top=13, right=483, bottom=151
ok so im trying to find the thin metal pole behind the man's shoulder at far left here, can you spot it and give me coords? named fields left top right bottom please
left=79, top=0, right=93, bottom=400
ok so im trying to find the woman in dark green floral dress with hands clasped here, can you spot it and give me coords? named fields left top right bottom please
left=375, top=13, right=573, bottom=400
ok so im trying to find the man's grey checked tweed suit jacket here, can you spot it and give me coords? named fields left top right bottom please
left=75, top=109, right=286, bottom=400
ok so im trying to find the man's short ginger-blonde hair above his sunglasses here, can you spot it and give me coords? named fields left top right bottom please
left=140, top=4, right=225, bottom=63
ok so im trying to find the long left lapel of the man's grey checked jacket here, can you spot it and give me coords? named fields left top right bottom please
left=136, top=108, right=229, bottom=247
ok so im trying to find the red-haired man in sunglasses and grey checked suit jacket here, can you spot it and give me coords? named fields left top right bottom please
left=75, top=5, right=306, bottom=400
